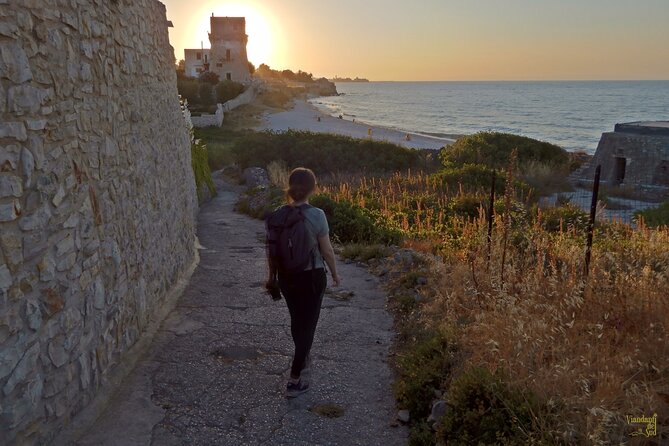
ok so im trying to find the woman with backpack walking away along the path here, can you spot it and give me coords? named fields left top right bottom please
left=266, top=168, right=340, bottom=398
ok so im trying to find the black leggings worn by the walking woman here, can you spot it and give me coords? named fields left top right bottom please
left=279, top=268, right=327, bottom=376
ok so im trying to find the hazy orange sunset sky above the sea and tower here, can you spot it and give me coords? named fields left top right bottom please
left=162, top=0, right=669, bottom=81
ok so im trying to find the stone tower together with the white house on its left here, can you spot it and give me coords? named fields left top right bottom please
left=184, top=14, right=251, bottom=83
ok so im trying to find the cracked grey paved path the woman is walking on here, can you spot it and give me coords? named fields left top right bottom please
left=77, top=178, right=407, bottom=446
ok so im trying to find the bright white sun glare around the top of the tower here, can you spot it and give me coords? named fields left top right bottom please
left=189, top=2, right=280, bottom=66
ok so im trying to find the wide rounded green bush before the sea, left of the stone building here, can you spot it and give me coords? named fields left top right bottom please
left=441, top=132, right=570, bottom=171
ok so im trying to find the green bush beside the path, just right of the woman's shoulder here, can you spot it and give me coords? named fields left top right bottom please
left=310, top=194, right=402, bottom=245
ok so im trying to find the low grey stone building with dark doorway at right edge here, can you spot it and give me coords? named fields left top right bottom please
left=590, top=121, right=669, bottom=186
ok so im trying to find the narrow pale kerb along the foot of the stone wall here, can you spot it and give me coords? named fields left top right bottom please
left=48, top=236, right=200, bottom=446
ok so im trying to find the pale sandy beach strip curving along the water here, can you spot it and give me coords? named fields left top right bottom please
left=257, top=100, right=455, bottom=149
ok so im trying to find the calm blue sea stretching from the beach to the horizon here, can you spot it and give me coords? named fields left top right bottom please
left=312, top=81, right=669, bottom=153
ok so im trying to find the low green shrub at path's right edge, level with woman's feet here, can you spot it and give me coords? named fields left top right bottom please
left=393, top=333, right=455, bottom=422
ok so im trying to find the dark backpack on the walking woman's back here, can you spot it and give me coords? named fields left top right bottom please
left=265, top=204, right=318, bottom=273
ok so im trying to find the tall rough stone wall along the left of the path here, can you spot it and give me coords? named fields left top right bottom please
left=0, top=0, right=197, bottom=444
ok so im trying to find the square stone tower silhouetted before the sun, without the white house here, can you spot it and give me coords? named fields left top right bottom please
left=209, top=14, right=251, bottom=83
